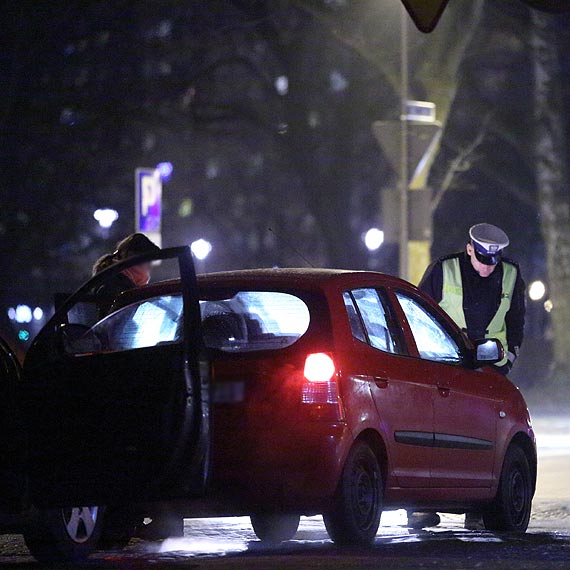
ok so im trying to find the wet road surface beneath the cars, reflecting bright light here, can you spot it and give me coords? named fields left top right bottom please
left=0, top=416, right=570, bottom=570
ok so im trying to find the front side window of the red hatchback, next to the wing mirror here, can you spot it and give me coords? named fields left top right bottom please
left=396, top=292, right=461, bottom=363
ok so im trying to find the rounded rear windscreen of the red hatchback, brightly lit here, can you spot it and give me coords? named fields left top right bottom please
left=200, top=291, right=311, bottom=352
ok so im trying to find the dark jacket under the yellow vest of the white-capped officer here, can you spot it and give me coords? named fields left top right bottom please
left=419, top=252, right=526, bottom=350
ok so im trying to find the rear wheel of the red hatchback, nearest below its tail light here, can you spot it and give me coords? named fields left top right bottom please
left=323, top=442, right=383, bottom=544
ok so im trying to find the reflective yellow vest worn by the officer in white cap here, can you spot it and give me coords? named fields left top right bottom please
left=439, top=257, right=517, bottom=366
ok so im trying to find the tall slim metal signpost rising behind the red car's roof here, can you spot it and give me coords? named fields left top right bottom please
left=398, top=6, right=409, bottom=280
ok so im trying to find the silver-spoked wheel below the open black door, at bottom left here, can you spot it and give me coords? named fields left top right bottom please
left=24, top=507, right=105, bottom=563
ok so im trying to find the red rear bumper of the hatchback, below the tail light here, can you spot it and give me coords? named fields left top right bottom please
left=210, top=423, right=352, bottom=514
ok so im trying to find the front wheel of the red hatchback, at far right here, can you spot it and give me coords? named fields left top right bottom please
left=483, top=445, right=533, bottom=532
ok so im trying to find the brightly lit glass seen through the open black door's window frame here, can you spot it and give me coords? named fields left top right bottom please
left=64, top=295, right=183, bottom=354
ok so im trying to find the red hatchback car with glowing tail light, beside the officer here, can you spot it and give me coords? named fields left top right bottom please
left=195, top=269, right=536, bottom=543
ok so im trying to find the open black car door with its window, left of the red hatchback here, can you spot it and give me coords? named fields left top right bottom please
left=21, top=247, right=209, bottom=507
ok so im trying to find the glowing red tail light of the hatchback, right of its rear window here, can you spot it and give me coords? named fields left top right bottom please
left=302, top=352, right=343, bottom=421
